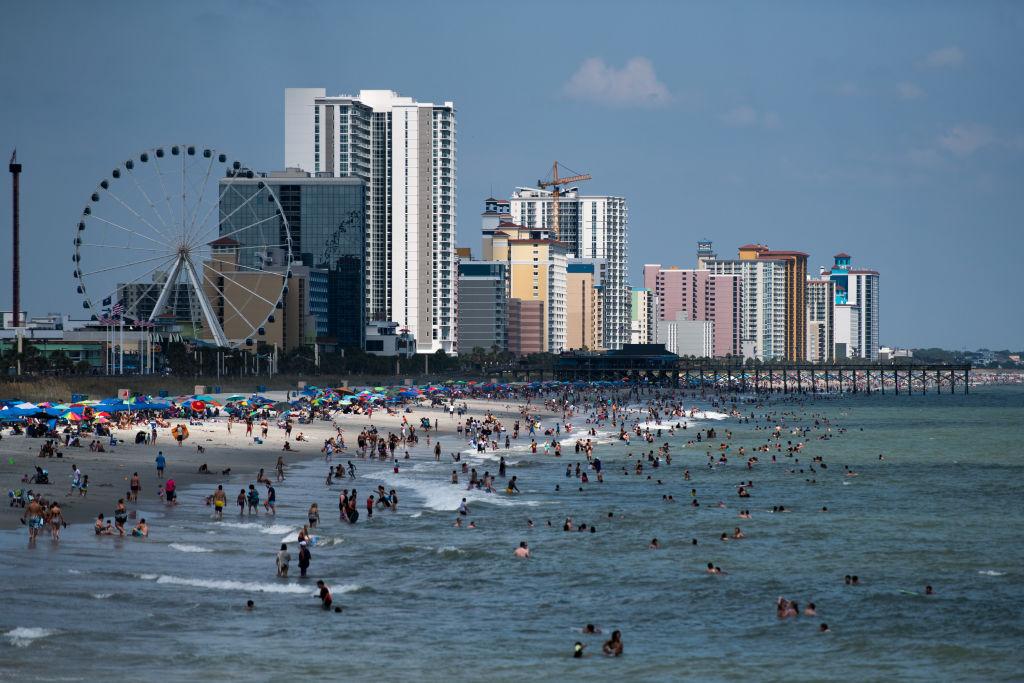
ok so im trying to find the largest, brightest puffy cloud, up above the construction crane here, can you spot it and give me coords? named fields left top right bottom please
left=562, top=57, right=672, bottom=106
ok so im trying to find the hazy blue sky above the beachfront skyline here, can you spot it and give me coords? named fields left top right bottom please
left=0, top=0, right=1024, bottom=349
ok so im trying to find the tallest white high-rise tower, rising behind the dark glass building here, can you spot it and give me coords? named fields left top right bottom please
left=285, top=88, right=458, bottom=353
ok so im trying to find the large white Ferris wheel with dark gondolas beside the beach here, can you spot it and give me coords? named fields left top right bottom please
left=73, top=144, right=293, bottom=347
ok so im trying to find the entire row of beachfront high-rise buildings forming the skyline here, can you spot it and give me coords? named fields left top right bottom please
left=0, top=88, right=881, bottom=362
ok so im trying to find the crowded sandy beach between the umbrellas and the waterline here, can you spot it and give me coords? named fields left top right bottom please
left=0, top=391, right=543, bottom=529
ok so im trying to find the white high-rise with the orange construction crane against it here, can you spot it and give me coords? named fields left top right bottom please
left=510, top=187, right=631, bottom=349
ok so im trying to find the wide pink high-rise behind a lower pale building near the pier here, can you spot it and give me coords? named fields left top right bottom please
left=643, top=263, right=743, bottom=357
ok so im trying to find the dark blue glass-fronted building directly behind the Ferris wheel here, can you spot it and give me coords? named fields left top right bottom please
left=219, top=169, right=367, bottom=347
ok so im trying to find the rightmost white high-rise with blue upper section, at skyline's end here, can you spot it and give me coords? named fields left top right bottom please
left=828, top=253, right=879, bottom=360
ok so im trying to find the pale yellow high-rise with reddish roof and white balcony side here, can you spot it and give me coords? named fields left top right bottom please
left=484, top=221, right=568, bottom=353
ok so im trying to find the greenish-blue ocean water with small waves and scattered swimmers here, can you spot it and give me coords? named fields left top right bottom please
left=0, top=387, right=1024, bottom=681
